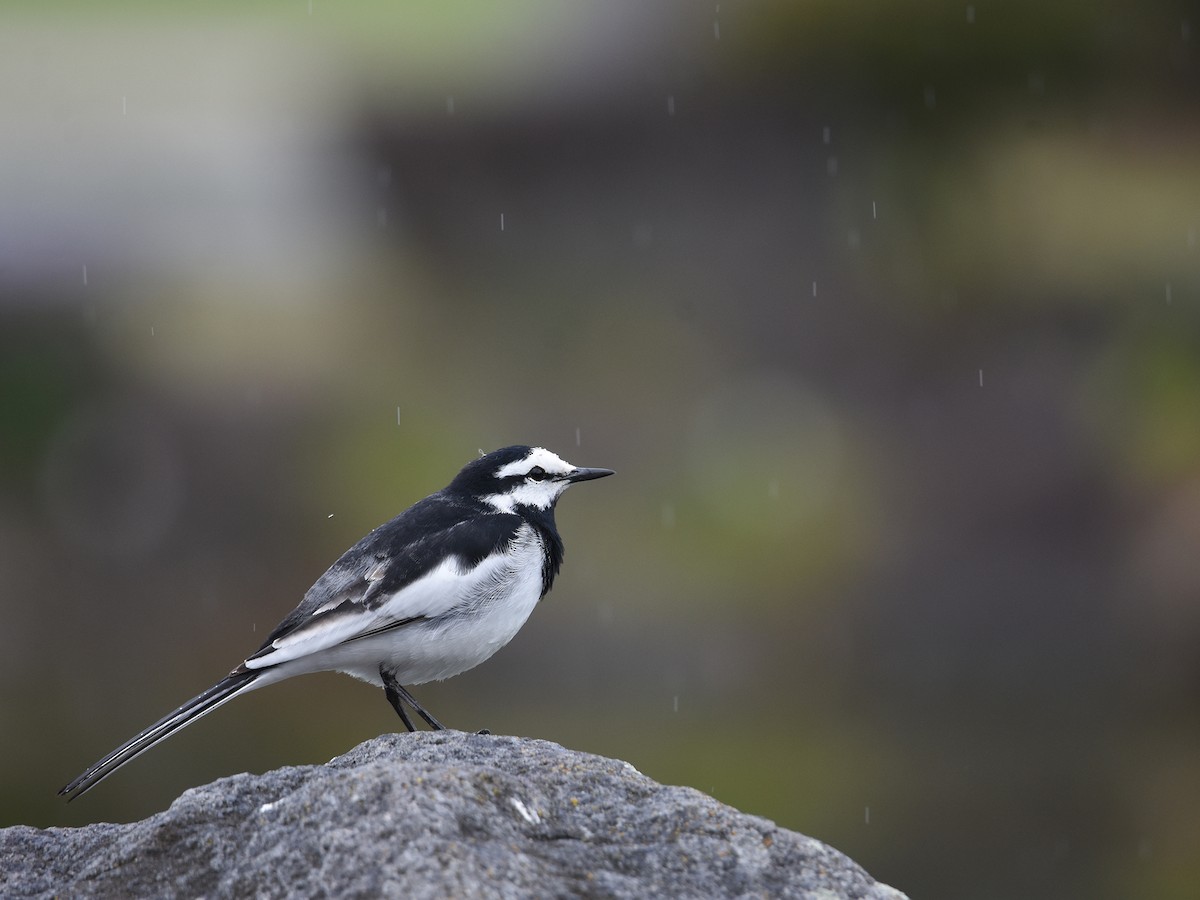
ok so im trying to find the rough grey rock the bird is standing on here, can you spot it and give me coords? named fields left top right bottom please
left=0, top=732, right=904, bottom=900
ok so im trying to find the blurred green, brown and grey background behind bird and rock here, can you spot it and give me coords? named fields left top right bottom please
left=0, top=0, right=1200, bottom=898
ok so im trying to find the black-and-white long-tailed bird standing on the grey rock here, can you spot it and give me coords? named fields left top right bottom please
left=59, top=445, right=613, bottom=799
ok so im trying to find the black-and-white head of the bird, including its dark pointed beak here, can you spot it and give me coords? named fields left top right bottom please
left=448, top=446, right=613, bottom=512
